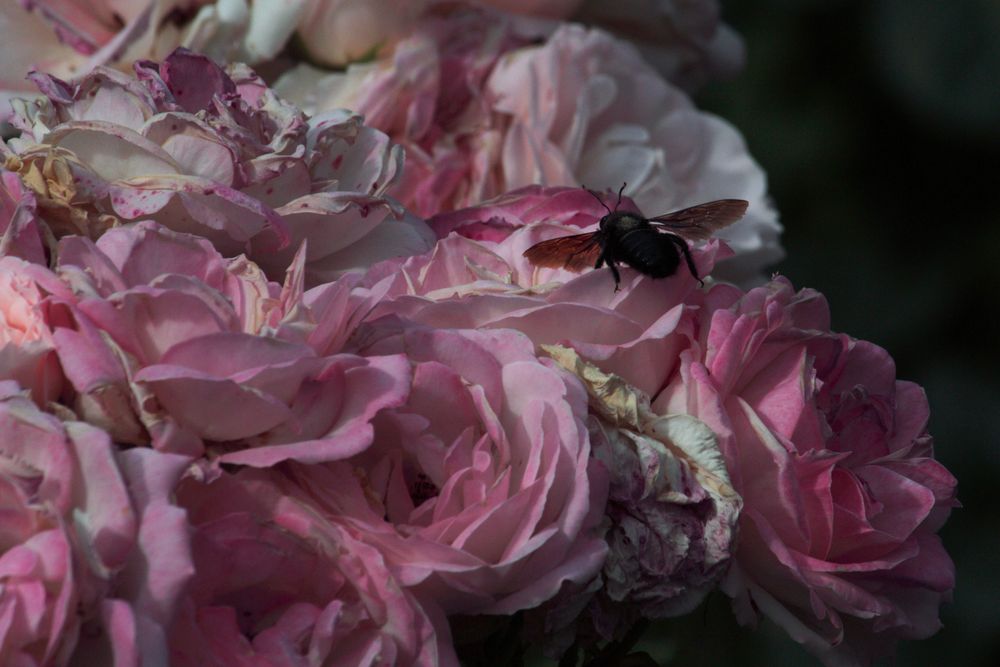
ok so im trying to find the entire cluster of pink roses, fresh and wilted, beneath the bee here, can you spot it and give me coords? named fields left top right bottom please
left=0, top=0, right=956, bottom=667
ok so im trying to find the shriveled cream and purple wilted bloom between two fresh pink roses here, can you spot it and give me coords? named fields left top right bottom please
left=545, top=346, right=742, bottom=639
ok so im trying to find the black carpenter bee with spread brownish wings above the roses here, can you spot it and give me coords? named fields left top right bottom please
left=524, top=183, right=747, bottom=292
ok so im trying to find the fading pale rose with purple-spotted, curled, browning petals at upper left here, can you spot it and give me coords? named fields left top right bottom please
left=8, top=51, right=429, bottom=283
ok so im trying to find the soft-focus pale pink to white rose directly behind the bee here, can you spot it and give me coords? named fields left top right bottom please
left=486, top=25, right=782, bottom=281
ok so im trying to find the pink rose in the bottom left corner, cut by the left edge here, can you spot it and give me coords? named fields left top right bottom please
left=0, top=381, right=135, bottom=665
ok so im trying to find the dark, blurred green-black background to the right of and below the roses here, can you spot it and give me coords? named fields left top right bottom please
left=661, top=0, right=1000, bottom=667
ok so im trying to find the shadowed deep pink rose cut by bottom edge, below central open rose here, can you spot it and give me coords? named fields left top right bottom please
left=169, top=470, right=458, bottom=667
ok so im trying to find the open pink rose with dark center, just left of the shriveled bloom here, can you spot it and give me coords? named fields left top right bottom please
left=284, top=326, right=607, bottom=614
